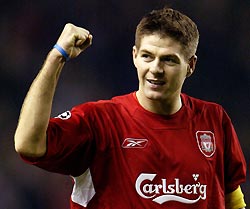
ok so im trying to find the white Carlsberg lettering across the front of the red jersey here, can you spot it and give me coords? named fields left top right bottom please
left=135, top=173, right=207, bottom=204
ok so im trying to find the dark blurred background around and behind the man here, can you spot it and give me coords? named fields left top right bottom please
left=0, top=0, right=250, bottom=209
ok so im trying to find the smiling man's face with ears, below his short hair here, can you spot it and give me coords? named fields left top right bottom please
left=133, top=35, right=196, bottom=109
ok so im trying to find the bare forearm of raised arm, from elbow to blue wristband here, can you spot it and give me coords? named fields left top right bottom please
left=15, top=49, right=64, bottom=157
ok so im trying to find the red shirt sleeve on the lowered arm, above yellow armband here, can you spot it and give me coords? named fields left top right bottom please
left=223, top=111, right=246, bottom=194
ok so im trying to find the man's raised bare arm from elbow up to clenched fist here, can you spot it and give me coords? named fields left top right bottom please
left=14, top=24, right=92, bottom=157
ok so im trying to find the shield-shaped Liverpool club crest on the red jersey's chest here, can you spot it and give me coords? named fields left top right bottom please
left=196, top=131, right=216, bottom=157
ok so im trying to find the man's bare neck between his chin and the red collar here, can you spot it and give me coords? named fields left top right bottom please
left=136, top=91, right=182, bottom=115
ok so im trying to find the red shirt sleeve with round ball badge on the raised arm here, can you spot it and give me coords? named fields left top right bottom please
left=22, top=105, right=95, bottom=176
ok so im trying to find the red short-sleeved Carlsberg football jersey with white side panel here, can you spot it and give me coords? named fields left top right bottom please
left=23, top=93, right=246, bottom=209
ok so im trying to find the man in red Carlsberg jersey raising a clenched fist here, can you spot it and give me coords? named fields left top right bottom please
left=15, top=8, right=246, bottom=209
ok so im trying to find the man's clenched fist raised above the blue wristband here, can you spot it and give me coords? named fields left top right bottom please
left=57, top=23, right=93, bottom=58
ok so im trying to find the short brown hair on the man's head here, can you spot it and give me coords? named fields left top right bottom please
left=135, top=7, right=199, bottom=59
